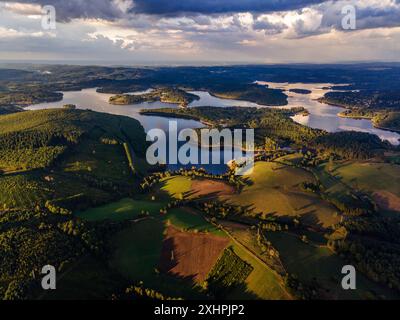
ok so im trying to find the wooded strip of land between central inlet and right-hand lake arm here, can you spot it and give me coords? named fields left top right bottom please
left=141, top=107, right=392, bottom=159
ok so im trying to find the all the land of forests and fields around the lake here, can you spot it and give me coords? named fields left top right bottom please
left=0, top=65, right=400, bottom=300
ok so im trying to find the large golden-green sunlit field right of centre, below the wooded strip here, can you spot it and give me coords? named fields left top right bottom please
left=222, top=162, right=339, bottom=227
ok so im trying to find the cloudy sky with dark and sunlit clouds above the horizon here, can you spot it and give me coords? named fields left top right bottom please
left=0, top=0, right=400, bottom=64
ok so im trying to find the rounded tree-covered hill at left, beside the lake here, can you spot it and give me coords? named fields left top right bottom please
left=0, top=109, right=146, bottom=208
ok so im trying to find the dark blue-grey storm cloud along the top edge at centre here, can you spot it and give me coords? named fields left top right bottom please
left=132, top=0, right=326, bottom=16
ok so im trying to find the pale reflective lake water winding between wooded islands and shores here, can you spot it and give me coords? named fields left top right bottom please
left=26, top=82, right=400, bottom=174
